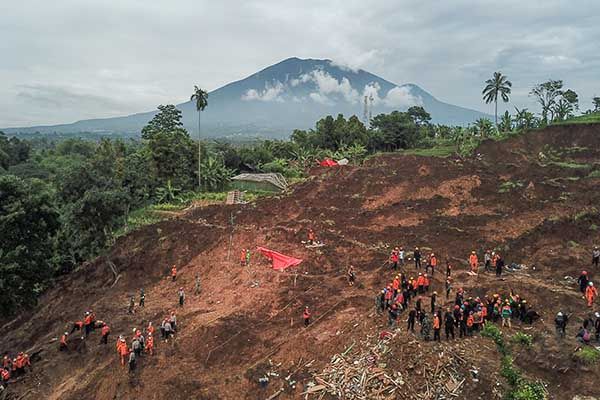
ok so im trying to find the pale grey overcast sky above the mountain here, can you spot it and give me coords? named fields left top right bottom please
left=0, top=0, right=600, bottom=127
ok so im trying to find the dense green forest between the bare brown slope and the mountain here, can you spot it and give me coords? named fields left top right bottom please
left=0, top=81, right=600, bottom=316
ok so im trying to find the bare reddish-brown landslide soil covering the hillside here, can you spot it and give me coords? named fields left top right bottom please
left=0, top=125, right=600, bottom=400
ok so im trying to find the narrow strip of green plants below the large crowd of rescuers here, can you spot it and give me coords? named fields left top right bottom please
left=481, top=324, right=548, bottom=400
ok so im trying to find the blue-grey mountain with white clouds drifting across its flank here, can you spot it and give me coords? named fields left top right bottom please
left=3, top=58, right=490, bottom=137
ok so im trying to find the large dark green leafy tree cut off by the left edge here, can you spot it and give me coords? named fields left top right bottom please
left=0, top=175, right=59, bottom=316
